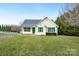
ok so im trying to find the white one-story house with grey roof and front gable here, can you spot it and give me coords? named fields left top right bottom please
left=21, top=17, right=58, bottom=35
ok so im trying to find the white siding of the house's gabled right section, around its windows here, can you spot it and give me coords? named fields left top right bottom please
left=35, top=18, right=58, bottom=35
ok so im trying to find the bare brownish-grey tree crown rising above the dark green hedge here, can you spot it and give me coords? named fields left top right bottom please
left=59, top=3, right=79, bottom=26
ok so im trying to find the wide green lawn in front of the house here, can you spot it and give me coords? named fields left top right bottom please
left=0, top=35, right=79, bottom=56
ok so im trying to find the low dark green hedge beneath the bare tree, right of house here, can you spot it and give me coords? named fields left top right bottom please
left=58, top=26, right=79, bottom=36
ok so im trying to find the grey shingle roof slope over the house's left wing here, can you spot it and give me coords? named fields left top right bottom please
left=22, top=19, right=42, bottom=27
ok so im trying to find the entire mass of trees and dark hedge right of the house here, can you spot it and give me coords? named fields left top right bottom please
left=55, top=4, right=79, bottom=36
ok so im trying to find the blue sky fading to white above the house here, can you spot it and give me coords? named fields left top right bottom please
left=0, top=3, right=65, bottom=25
